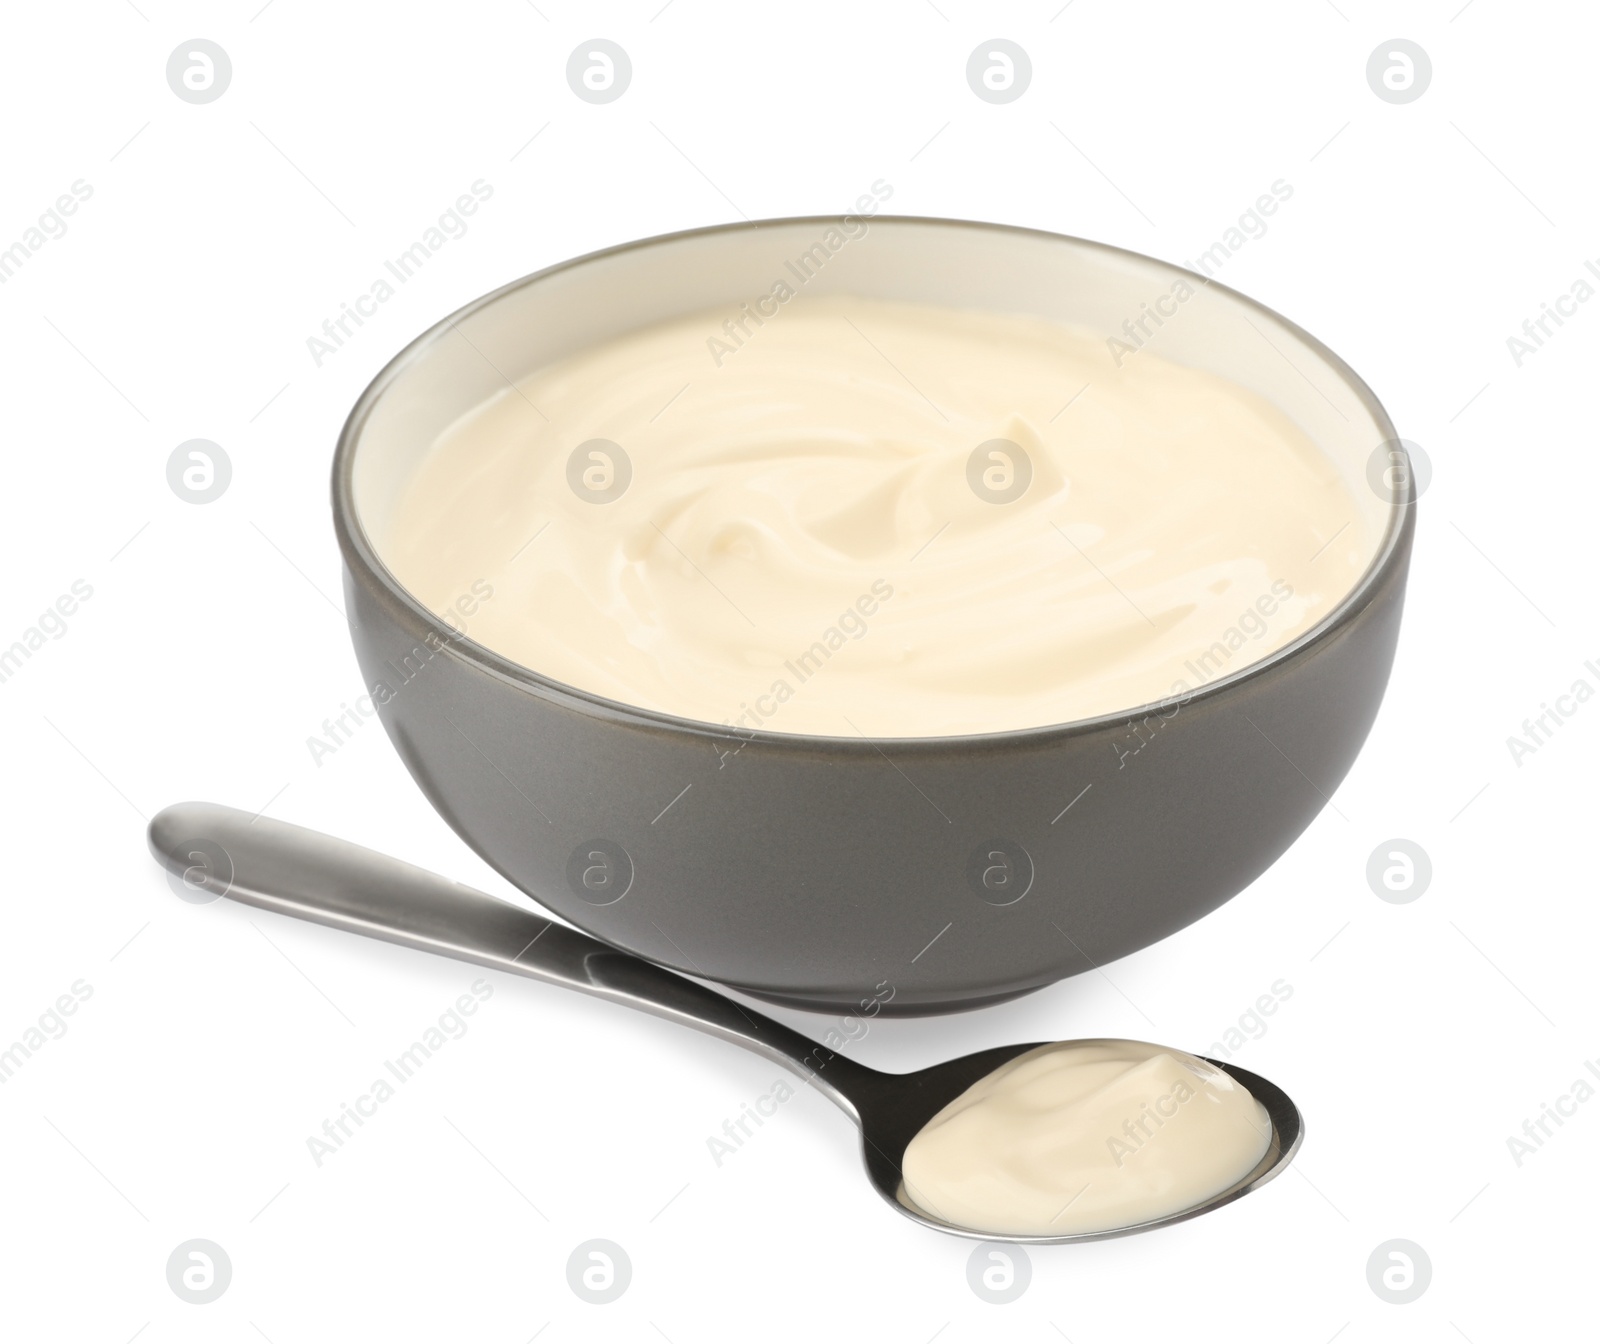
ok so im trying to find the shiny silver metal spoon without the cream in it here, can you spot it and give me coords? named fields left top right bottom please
left=150, top=803, right=1304, bottom=1243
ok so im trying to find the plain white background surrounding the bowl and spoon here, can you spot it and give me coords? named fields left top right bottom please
left=0, top=0, right=1600, bottom=1344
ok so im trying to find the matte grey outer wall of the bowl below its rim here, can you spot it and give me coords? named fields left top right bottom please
left=341, top=509, right=1414, bottom=1014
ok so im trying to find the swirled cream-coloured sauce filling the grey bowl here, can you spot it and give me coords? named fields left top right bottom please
left=378, top=296, right=1374, bottom=738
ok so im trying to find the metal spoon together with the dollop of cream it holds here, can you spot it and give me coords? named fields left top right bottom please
left=149, top=803, right=1302, bottom=1243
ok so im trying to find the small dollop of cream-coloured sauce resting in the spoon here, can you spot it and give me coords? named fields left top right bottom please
left=902, top=1040, right=1272, bottom=1237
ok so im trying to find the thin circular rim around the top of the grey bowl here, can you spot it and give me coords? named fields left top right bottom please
left=333, top=211, right=1418, bottom=755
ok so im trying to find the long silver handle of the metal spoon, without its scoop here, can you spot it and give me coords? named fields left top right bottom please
left=149, top=803, right=872, bottom=1120
